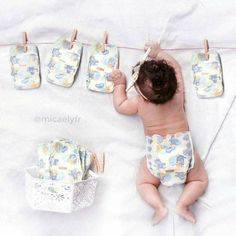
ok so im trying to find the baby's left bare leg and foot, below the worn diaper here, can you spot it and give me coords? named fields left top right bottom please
left=136, top=158, right=168, bottom=224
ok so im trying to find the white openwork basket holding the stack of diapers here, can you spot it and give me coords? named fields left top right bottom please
left=25, top=166, right=99, bottom=213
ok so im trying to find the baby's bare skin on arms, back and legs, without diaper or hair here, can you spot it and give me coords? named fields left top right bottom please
left=112, top=43, right=208, bottom=224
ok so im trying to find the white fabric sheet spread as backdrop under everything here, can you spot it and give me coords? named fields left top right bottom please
left=0, top=0, right=236, bottom=236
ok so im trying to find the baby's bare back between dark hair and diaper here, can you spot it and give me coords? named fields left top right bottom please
left=138, top=92, right=188, bottom=136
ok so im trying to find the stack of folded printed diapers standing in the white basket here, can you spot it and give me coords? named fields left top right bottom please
left=38, top=139, right=93, bottom=183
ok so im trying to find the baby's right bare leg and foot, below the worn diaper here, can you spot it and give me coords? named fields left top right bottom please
left=176, top=152, right=208, bottom=223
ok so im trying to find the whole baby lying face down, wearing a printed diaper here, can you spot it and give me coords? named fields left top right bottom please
left=111, top=43, right=208, bottom=224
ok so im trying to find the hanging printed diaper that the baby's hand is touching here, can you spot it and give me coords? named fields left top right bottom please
left=87, top=43, right=118, bottom=93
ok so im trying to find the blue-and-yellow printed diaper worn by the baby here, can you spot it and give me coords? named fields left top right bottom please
left=146, top=131, right=194, bottom=186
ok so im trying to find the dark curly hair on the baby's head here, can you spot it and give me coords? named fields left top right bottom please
left=136, top=60, right=177, bottom=104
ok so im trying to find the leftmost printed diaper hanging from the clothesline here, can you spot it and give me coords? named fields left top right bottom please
left=10, top=44, right=40, bottom=89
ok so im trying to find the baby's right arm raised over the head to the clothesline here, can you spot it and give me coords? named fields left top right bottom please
left=145, top=43, right=184, bottom=92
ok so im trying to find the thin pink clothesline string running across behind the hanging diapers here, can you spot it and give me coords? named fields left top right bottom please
left=0, top=42, right=236, bottom=51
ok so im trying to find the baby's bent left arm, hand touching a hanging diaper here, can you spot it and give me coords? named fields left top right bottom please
left=111, top=70, right=139, bottom=115
